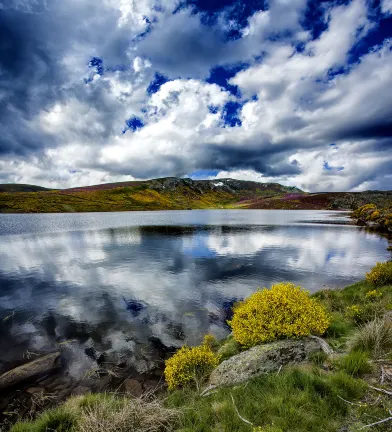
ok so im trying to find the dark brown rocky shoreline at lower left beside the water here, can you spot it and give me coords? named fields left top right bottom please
left=0, top=351, right=164, bottom=432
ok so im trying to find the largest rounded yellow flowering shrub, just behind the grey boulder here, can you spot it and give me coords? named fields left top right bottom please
left=228, top=282, right=329, bottom=347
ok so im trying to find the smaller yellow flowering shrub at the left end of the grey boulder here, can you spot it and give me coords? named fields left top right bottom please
left=165, top=343, right=219, bottom=390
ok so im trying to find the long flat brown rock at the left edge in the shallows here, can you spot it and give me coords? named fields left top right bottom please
left=0, top=352, right=60, bottom=389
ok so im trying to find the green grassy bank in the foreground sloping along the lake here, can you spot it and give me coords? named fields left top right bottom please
left=6, top=272, right=392, bottom=432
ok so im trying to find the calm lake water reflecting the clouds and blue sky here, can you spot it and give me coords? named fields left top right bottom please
left=0, top=210, right=390, bottom=375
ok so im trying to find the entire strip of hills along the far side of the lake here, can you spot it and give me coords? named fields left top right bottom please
left=0, top=177, right=392, bottom=213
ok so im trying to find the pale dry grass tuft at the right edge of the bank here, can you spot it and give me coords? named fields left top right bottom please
left=350, top=317, right=392, bottom=358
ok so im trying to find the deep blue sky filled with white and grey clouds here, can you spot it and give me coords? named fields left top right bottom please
left=0, top=0, right=392, bottom=191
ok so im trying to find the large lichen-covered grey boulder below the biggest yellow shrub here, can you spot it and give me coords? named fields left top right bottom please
left=210, top=337, right=325, bottom=387
